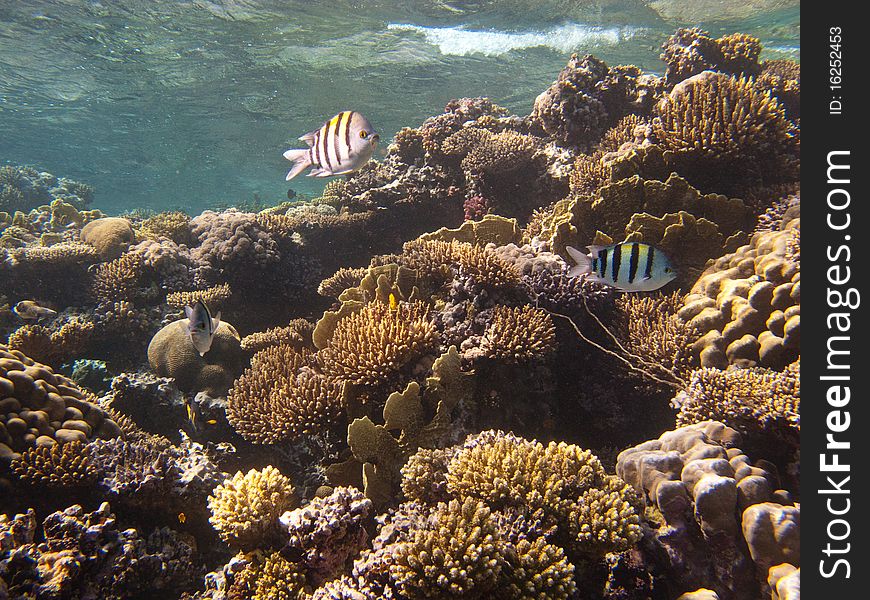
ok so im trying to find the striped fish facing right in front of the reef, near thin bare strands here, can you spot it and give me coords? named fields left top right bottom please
left=565, top=242, right=677, bottom=292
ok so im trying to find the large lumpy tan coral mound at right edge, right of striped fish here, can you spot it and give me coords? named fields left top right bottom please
left=678, top=219, right=800, bottom=369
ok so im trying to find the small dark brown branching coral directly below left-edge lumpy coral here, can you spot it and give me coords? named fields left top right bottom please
left=12, top=442, right=98, bottom=487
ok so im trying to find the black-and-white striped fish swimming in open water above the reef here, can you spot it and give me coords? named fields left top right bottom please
left=284, top=110, right=381, bottom=181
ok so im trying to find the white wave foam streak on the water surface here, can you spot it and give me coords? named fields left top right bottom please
left=387, top=23, right=639, bottom=56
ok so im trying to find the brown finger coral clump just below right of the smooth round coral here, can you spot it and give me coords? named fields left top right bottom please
left=227, top=344, right=342, bottom=444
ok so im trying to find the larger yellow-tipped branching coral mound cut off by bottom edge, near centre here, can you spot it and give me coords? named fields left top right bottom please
left=390, top=499, right=505, bottom=598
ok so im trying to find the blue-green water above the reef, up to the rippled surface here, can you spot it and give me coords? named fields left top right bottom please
left=0, top=0, right=800, bottom=213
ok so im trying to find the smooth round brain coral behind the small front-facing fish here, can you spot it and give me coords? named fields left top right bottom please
left=148, top=319, right=245, bottom=396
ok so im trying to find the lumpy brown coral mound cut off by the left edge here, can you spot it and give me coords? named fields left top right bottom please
left=0, top=344, right=121, bottom=459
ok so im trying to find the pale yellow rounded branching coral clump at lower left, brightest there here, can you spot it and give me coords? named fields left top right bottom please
left=208, top=465, right=299, bottom=549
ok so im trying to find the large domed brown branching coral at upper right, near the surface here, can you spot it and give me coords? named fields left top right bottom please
left=652, top=71, right=798, bottom=191
